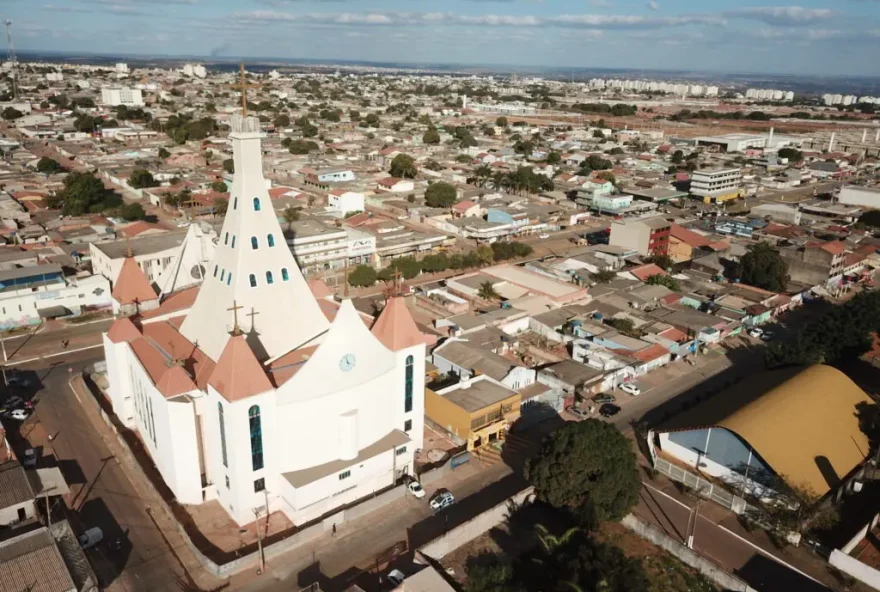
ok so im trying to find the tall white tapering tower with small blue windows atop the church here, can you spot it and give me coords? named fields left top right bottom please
left=180, top=115, right=329, bottom=361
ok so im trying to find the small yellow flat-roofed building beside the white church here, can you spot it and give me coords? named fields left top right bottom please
left=425, top=376, right=522, bottom=450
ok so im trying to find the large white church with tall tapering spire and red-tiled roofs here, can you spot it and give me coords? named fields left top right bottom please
left=104, top=116, right=426, bottom=525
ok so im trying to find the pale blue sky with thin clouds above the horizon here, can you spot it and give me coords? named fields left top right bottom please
left=0, top=0, right=880, bottom=75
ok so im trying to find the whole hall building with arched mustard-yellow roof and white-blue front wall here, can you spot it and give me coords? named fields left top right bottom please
left=649, top=365, right=873, bottom=496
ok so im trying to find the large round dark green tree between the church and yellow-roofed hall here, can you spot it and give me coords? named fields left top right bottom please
left=525, top=419, right=641, bottom=521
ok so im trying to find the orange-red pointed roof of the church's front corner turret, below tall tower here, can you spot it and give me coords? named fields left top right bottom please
left=208, top=335, right=272, bottom=401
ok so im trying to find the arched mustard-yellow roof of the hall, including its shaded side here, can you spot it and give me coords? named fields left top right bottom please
left=676, top=365, right=873, bottom=496
